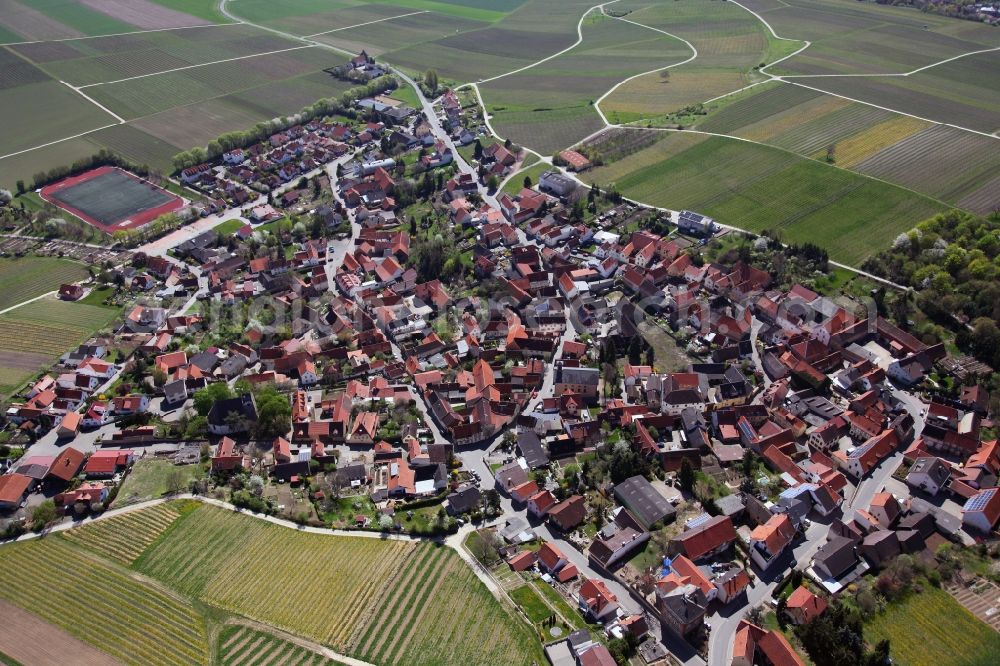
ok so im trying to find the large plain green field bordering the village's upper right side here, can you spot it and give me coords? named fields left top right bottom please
left=586, top=134, right=946, bottom=265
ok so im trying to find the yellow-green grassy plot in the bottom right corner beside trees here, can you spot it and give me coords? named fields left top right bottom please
left=865, top=585, right=1000, bottom=666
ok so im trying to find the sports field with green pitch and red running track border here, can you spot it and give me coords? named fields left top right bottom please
left=41, top=167, right=184, bottom=233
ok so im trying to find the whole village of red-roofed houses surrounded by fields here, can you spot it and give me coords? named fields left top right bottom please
left=0, top=48, right=1000, bottom=666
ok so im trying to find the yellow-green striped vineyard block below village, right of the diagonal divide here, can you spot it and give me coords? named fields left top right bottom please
left=134, top=506, right=538, bottom=664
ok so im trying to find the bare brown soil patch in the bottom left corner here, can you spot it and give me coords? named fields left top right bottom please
left=0, top=601, right=118, bottom=666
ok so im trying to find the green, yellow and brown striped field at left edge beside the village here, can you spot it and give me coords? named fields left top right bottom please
left=0, top=297, right=118, bottom=398
